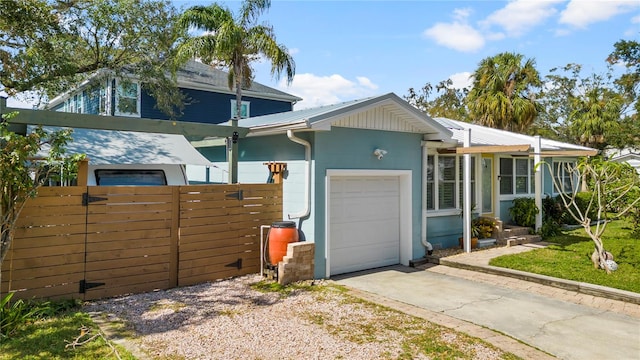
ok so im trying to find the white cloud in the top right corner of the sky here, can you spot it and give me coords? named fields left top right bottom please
left=559, top=0, right=640, bottom=29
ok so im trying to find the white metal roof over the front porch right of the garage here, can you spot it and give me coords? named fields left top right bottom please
left=434, top=117, right=594, bottom=151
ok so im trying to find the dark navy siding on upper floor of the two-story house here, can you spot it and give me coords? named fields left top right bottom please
left=141, top=89, right=293, bottom=124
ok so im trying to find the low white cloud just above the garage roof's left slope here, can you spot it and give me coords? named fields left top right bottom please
left=278, top=73, right=378, bottom=110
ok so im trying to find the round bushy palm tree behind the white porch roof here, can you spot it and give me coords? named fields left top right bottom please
left=467, top=52, right=542, bottom=132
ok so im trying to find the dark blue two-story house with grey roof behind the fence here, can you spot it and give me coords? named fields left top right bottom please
left=47, top=61, right=302, bottom=124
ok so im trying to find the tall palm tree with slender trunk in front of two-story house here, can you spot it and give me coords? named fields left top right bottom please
left=178, top=0, right=295, bottom=183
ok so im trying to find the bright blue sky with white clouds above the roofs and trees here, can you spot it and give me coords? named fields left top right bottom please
left=9, top=0, right=640, bottom=109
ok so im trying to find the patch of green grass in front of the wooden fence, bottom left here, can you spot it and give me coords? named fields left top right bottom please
left=0, top=309, right=135, bottom=360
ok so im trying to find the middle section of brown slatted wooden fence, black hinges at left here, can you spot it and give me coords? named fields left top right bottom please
left=79, top=186, right=178, bottom=300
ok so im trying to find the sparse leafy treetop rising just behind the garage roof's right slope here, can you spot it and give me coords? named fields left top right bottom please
left=404, top=79, right=469, bottom=121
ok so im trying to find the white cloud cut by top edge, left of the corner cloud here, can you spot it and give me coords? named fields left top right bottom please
left=482, top=0, right=563, bottom=37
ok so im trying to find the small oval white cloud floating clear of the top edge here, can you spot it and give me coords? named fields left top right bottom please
left=423, top=21, right=485, bottom=52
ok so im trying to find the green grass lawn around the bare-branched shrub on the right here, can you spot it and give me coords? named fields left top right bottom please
left=489, top=220, right=640, bottom=293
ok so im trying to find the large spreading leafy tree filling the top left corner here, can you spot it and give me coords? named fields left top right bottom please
left=0, top=0, right=184, bottom=116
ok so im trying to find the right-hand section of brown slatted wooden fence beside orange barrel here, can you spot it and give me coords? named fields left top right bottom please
left=178, top=184, right=282, bottom=286
